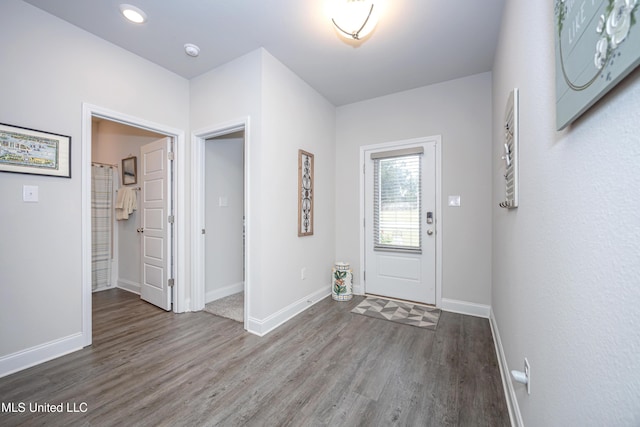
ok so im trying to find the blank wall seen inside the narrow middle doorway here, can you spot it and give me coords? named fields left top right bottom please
left=205, top=135, right=244, bottom=302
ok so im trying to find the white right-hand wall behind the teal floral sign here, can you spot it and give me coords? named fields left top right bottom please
left=492, top=1, right=640, bottom=427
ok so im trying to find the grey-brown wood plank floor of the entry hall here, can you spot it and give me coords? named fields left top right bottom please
left=0, top=289, right=509, bottom=427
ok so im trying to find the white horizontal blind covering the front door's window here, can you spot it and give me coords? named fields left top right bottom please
left=371, top=152, right=422, bottom=253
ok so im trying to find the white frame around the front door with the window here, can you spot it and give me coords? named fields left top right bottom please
left=353, top=135, right=442, bottom=307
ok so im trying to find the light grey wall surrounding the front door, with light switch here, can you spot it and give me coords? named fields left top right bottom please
left=335, top=73, right=491, bottom=305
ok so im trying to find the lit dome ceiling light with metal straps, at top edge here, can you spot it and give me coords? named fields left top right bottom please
left=330, top=0, right=379, bottom=40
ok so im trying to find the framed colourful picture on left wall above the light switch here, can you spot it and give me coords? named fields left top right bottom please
left=0, top=123, right=71, bottom=178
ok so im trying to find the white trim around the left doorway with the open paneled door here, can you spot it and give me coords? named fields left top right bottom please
left=80, top=103, right=187, bottom=347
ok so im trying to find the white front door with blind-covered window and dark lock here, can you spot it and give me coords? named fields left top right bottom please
left=364, top=141, right=437, bottom=304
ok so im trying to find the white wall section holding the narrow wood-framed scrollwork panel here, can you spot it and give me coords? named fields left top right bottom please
left=259, top=51, right=335, bottom=317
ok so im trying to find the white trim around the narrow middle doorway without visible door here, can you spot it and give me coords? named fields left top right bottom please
left=191, top=116, right=251, bottom=330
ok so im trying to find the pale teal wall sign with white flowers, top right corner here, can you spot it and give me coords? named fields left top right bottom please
left=554, top=0, right=640, bottom=130
